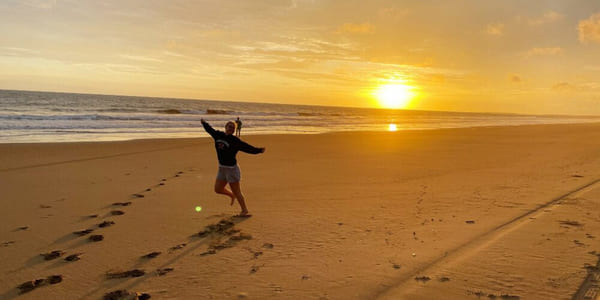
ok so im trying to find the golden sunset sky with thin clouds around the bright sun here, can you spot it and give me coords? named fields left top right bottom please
left=0, top=0, right=600, bottom=115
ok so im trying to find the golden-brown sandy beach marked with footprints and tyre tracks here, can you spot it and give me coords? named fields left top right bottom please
left=0, top=124, right=600, bottom=299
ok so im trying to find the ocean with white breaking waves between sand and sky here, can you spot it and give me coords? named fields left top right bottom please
left=0, top=90, right=600, bottom=143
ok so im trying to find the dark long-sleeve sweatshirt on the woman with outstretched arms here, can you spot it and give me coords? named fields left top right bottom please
left=202, top=122, right=262, bottom=166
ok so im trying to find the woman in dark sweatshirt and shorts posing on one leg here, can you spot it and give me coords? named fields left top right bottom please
left=200, top=119, right=265, bottom=217
